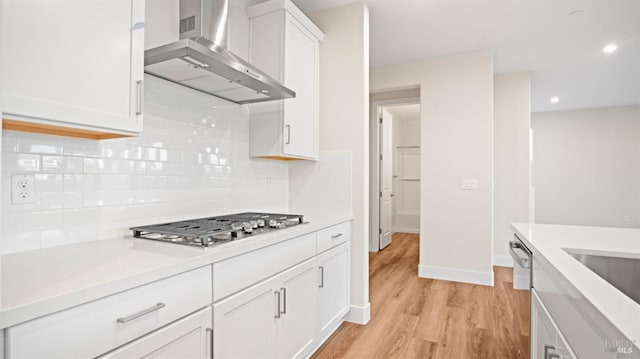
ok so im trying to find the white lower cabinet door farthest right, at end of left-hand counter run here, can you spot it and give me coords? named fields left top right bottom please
left=316, top=242, right=349, bottom=341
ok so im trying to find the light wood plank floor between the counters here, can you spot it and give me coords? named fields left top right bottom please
left=313, top=233, right=529, bottom=359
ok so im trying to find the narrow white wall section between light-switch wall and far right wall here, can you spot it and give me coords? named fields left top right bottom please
left=493, top=72, right=531, bottom=266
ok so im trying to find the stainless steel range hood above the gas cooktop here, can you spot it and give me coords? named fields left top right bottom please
left=144, top=0, right=296, bottom=104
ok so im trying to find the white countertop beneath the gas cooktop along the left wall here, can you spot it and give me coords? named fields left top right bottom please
left=0, top=217, right=351, bottom=329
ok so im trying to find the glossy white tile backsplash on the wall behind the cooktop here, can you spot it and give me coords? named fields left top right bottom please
left=1, top=76, right=289, bottom=253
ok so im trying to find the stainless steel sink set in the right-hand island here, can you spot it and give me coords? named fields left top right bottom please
left=565, top=249, right=640, bottom=304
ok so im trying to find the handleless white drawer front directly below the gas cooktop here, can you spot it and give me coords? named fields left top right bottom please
left=213, top=232, right=316, bottom=302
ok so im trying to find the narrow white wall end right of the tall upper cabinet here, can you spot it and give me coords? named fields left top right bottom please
left=309, top=2, right=369, bottom=323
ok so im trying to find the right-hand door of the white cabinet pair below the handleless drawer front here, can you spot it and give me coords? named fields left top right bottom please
left=276, top=261, right=315, bottom=359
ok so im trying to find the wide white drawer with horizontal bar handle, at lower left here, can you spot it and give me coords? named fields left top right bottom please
left=6, top=266, right=212, bottom=359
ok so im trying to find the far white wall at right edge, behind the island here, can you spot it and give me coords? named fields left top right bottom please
left=531, top=105, right=640, bottom=228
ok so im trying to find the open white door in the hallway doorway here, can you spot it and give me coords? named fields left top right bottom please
left=379, top=109, right=393, bottom=249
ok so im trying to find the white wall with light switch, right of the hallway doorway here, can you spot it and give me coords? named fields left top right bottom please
left=371, top=51, right=493, bottom=284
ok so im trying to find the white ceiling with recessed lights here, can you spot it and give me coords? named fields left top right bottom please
left=282, top=0, right=640, bottom=112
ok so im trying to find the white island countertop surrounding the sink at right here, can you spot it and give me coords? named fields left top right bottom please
left=512, top=223, right=640, bottom=345
